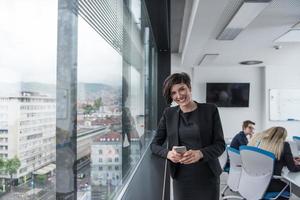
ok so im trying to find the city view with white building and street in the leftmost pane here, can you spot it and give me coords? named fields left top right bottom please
left=0, top=82, right=56, bottom=199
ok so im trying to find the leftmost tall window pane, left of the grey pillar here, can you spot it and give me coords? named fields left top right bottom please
left=0, top=0, right=57, bottom=199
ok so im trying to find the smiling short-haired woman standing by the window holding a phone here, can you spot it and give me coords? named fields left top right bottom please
left=151, top=73, right=225, bottom=200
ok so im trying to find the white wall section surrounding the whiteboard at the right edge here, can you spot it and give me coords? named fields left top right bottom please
left=264, top=65, right=300, bottom=138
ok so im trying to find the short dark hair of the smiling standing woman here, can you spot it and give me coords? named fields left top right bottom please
left=163, top=72, right=191, bottom=104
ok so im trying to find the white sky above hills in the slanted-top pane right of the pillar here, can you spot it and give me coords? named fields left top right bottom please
left=78, top=18, right=122, bottom=85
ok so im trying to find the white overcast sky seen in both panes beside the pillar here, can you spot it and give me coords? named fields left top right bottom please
left=0, top=0, right=122, bottom=84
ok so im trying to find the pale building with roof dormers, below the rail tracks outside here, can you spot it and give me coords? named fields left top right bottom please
left=91, top=131, right=122, bottom=199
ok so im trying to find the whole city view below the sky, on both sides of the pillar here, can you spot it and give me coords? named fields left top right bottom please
left=0, top=80, right=143, bottom=199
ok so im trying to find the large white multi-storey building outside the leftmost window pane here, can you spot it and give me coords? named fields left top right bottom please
left=0, top=92, right=56, bottom=183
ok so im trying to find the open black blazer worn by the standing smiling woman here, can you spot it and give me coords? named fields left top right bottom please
left=150, top=103, right=225, bottom=178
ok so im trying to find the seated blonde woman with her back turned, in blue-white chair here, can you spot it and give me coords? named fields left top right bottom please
left=248, top=127, right=300, bottom=199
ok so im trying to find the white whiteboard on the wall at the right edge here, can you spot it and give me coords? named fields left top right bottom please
left=270, top=89, right=300, bottom=121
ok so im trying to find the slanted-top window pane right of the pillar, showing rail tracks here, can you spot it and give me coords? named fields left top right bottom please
left=77, top=14, right=122, bottom=199
